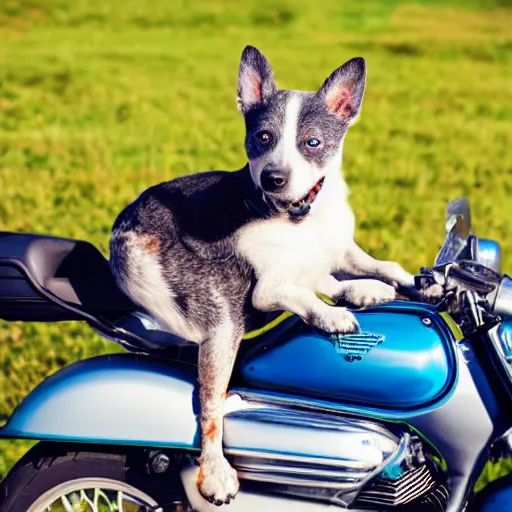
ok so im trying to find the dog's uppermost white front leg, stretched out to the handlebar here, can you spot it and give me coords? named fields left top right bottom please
left=337, top=242, right=414, bottom=288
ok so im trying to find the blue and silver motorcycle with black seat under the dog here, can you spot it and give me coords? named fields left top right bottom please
left=0, top=199, right=512, bottom=512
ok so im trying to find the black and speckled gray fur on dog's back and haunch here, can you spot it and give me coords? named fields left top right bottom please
left=110, top=167, right=275, bottom=332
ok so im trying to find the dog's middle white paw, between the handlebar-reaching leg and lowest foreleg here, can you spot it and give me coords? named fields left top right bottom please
left=318, top=276, right=396, bottom=307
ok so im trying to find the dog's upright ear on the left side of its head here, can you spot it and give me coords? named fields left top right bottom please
left=237, top=46, right=277, bottom=114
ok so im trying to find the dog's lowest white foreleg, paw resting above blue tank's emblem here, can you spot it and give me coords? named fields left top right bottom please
left=252, top=278, right=359, bottom=333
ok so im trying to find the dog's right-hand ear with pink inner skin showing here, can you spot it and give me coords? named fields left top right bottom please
left=318, top=57, right=366, bottom=122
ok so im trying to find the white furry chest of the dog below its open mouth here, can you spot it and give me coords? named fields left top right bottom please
left=237, top=202, right=354, bottom=288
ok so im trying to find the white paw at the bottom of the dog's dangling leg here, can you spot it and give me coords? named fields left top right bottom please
left=197, top=456, right=240, bottom=506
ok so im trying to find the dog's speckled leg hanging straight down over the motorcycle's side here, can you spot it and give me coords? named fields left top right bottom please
left=197, top=321, right=243, bottom=505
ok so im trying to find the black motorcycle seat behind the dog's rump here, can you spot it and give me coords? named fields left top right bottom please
left=0, top=232, right=204, bottom=360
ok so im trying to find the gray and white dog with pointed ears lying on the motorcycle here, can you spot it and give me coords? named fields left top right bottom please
left=110, top=46, right=414, bottom=505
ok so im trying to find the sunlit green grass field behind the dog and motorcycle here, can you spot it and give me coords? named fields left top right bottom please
left=0, top=0, right=512, bottom=492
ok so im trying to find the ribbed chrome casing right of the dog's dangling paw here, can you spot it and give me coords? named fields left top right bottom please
left=224, top=404, right=404, bottom=506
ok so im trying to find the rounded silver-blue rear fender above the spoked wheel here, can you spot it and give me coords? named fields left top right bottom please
left=0, top=354, right=200, bottom=449
